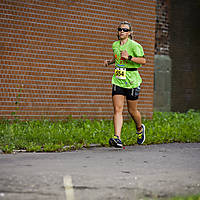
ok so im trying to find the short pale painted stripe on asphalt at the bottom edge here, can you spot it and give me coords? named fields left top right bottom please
left=63, top=176, right=74, bottom=200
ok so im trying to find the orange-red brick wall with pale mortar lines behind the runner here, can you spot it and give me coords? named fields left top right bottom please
left=0, top=0, right=156, bottom=119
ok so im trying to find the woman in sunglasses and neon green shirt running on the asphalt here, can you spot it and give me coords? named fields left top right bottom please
left=104, top=21, right=146, bottom=148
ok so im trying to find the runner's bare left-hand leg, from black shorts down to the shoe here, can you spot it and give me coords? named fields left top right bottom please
left=112, top=95, right=125, bottom=139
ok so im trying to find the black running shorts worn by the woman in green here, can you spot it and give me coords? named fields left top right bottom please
left=112, top=85, right=140, bottom=100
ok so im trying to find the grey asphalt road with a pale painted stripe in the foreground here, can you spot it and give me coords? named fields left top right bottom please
left=0, top=143, right=200, bottom=200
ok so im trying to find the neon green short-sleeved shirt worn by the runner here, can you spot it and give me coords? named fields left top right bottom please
left=112, top=39, right=144, bottom=88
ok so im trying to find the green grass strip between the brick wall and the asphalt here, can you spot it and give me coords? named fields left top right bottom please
left=0, top=110, right=200, bottom=153
